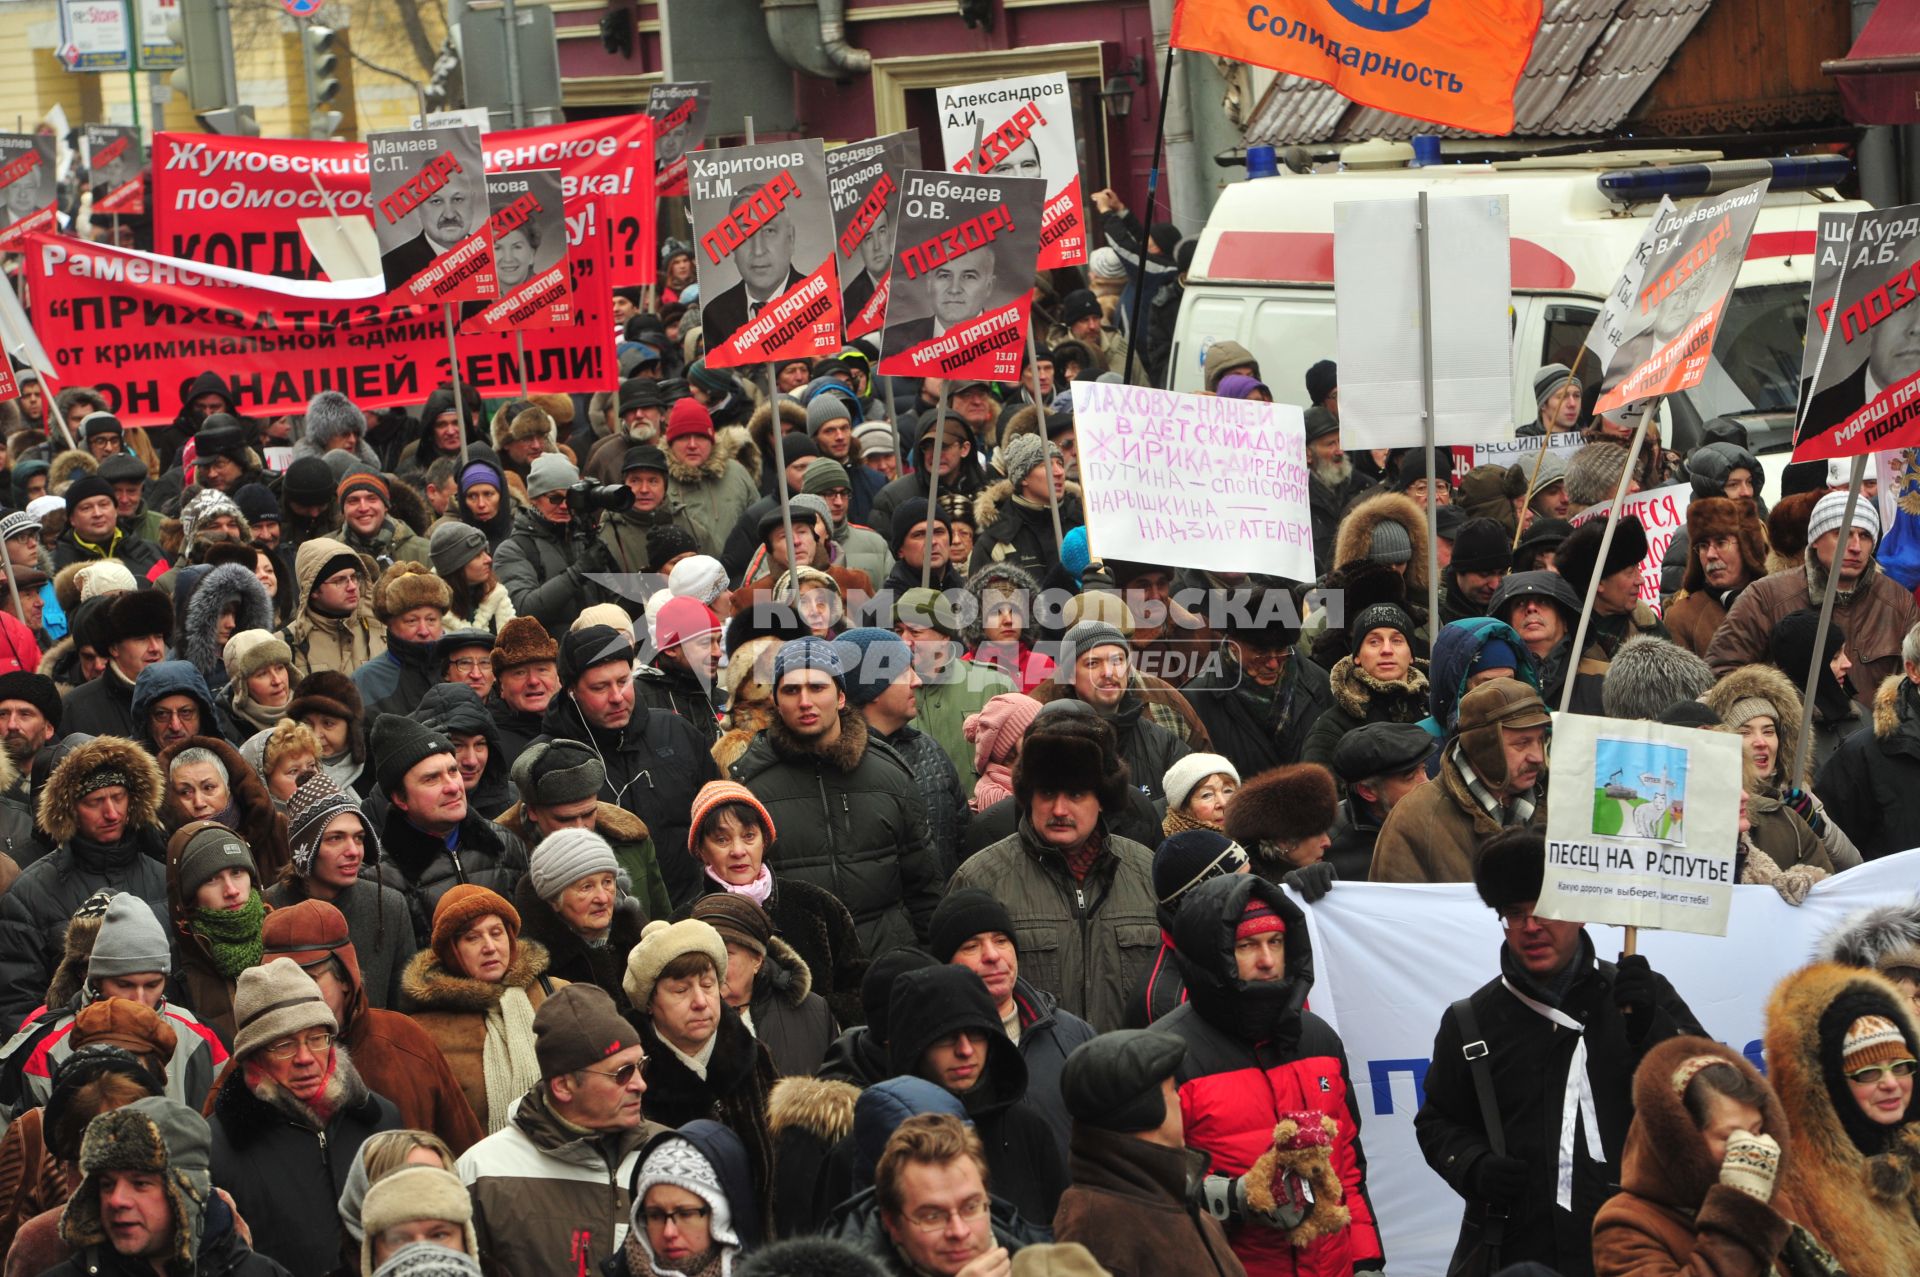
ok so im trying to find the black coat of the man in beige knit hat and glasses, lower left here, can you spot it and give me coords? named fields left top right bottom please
left=207, top=1048, right=401, bottom=1277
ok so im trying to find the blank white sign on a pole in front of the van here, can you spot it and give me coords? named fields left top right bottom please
left=1332, top=196, right=1515, bottom=451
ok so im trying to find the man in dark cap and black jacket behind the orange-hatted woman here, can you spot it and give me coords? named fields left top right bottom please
left=541, top=626, right=720, bottom=908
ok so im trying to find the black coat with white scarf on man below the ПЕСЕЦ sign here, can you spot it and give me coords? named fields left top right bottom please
left=1413, top=935, right=1705, bottom=1277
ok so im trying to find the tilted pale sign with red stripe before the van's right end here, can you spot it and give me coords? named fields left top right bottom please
left=1586, top=179, right=1766, bottom=415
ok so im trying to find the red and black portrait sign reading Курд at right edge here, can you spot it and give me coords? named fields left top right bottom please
left=1793, top=204, right=1920, bottom=461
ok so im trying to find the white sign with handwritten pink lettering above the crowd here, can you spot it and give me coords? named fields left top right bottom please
left=1073, top=382, right=1313, bottom=580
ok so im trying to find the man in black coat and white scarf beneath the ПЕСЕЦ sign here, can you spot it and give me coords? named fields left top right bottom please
left=1413, top=830, right=1705, bottom=1277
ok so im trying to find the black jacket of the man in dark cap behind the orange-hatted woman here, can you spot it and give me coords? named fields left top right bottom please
left=541, top=693, right=720, bottom=908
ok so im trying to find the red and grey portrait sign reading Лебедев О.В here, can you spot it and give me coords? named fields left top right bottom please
left=879, top=169, right=1046, bottom=382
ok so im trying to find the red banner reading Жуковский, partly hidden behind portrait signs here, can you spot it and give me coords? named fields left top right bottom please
left=154, top=115, right=657, bottom=286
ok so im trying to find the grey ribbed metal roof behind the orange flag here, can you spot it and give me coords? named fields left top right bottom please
left=1246, top=0, right=1713, bottom=144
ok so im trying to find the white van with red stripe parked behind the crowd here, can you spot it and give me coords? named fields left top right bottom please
left=1169, top=144, right=1870, bottom=451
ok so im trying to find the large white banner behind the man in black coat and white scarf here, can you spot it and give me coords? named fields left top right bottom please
left=1304, top=851, right=1920, bottom=1273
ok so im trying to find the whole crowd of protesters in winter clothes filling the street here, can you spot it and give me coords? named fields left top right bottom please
left=0, top=206, right=1920, bottom=1277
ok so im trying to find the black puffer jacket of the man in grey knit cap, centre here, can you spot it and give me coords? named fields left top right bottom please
left=725, top=709, right=945, bottom=954
